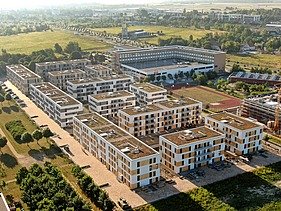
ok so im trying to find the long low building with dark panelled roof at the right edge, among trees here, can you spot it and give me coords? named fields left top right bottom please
left=228, top=72, right=281, bottom=86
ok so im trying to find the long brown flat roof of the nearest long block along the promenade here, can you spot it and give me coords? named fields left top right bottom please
left=75, top=112, right=157, bottom=159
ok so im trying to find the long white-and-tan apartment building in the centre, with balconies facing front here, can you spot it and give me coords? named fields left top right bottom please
left=118, top=98, right=202, bottom=137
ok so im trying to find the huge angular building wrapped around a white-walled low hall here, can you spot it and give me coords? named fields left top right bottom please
left=111, top=46, right=226, bottom=75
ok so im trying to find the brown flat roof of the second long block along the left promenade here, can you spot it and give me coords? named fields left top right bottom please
left=32, top=82, right=81, bottom=106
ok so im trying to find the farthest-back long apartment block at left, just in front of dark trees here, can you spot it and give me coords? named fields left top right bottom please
left=35, top=59, right=91, bottom=80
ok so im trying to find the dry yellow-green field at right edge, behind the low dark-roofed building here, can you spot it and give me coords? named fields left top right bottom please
left=226, top=54, right=281, bottom=71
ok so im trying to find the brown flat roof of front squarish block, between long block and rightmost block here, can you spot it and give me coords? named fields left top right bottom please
left=162, top=126, right=223, bottom=146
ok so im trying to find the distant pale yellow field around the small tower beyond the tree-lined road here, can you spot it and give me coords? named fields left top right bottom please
left=94, top=26, right=223, bottom=44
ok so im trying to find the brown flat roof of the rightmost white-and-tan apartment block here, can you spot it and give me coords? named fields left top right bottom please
left=208, top=112, right=260, bottom=130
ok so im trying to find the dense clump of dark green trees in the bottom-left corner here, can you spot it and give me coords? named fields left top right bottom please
left=16, top=162, right=91, bottom=211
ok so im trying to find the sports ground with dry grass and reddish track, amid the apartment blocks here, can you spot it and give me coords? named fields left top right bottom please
left=172, top=86, right=241, bottom=112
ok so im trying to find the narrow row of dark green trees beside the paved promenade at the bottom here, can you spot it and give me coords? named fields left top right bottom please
left=72, top=166, right=115, bottom=211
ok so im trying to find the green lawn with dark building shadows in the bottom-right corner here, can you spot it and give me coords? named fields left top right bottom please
left=135, top=162, right=281, bottom=211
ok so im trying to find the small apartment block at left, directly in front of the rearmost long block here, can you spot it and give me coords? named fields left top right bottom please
left=48, top=69, right=86, bottom=91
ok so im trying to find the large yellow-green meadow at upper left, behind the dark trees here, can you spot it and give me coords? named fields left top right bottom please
left=0, top=31, right=111, bottom=54
